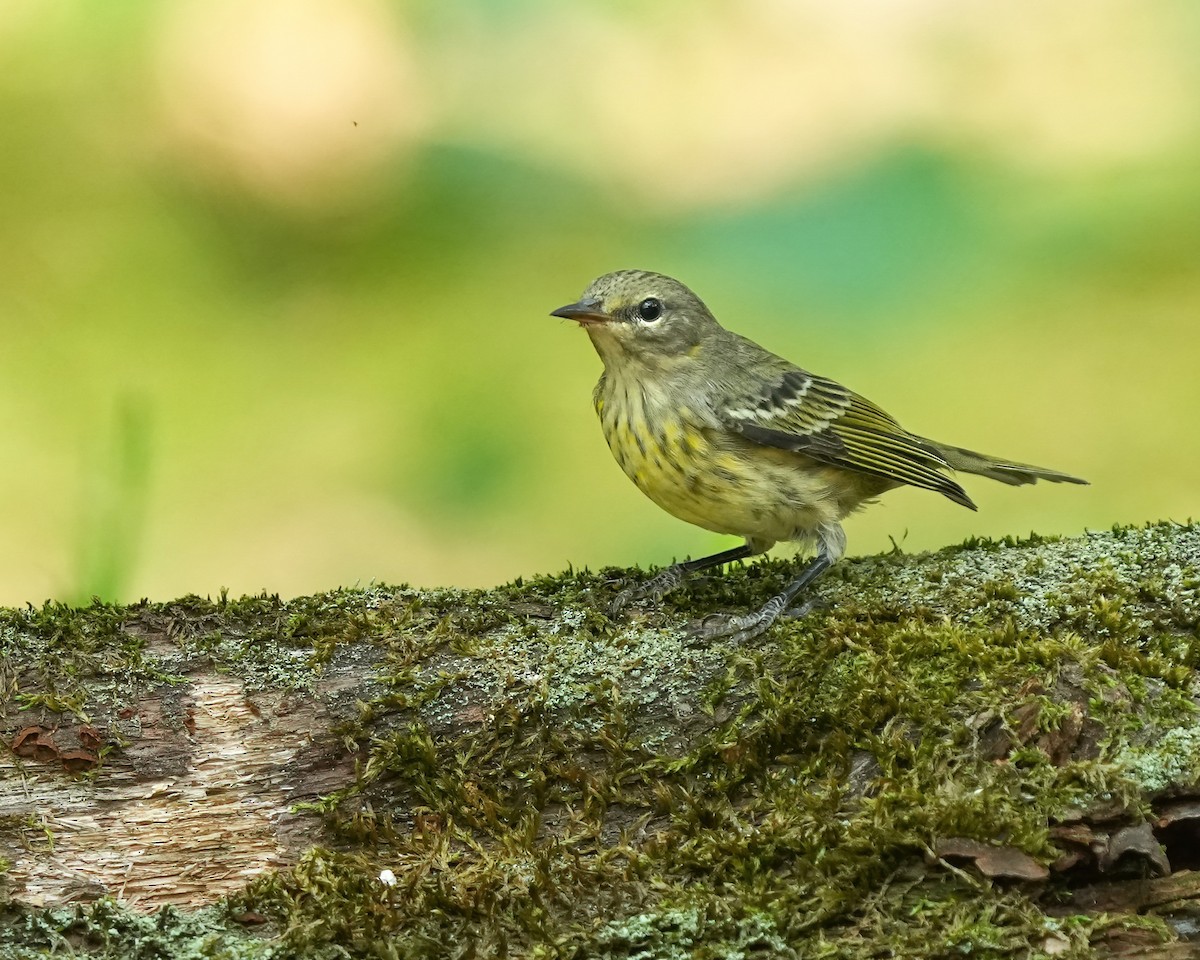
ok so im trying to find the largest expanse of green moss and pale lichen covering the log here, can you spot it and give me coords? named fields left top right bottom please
left=7, top=524, right=1200, bottom=960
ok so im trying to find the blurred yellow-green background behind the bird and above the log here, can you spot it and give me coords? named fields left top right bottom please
left=0, top=0, right=1200, bottom=604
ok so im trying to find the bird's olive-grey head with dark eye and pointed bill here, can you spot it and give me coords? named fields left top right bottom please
left=550, top=270, right=721, bottom=366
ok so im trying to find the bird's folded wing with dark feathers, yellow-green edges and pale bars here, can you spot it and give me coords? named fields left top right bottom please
left=719, top=367, right=974, bottom=510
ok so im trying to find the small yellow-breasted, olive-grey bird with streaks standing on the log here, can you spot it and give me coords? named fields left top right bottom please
left=551, top=270, right=1087, bottom=641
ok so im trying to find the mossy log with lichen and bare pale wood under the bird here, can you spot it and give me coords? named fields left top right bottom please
left=0, top=523, right=1200, bottom=960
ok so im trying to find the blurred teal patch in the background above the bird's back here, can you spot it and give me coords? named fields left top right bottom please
left=661, top=150, right=996, bottom=319
